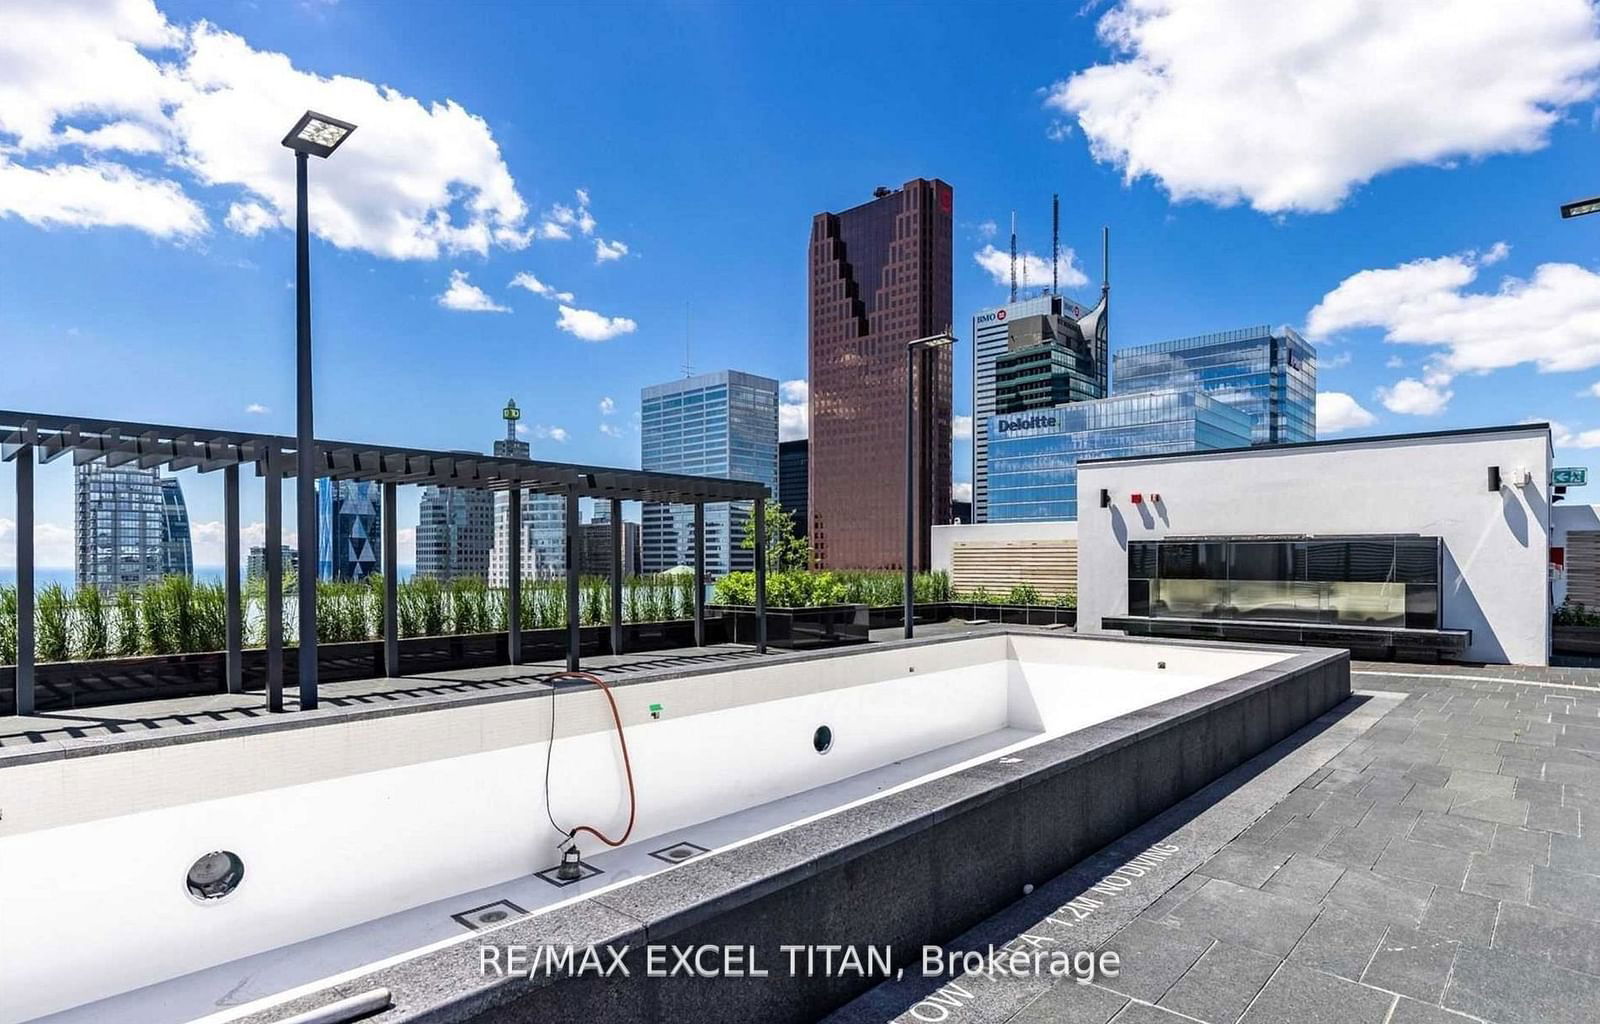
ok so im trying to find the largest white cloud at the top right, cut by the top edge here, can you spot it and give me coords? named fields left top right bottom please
left=1045, top=0, right=1600, bottom=213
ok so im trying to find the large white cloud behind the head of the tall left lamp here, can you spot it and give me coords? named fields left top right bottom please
left=0, top=0, right=531, bottom=259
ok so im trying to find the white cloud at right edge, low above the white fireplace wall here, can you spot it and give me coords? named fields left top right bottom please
left=1306, top=243, right=1600, bottom=382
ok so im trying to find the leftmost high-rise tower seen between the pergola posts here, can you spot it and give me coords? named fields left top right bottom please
left=72, top=462, right=166, bottom=590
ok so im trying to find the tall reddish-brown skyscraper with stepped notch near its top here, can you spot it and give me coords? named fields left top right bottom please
left=808, top=178, right=954, bottom=570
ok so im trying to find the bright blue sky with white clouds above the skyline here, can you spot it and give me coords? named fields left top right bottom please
left=0, top=0, right=1600, bottom=565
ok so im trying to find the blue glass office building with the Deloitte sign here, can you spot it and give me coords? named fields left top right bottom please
left=989, top=389, right=1254, bottom=523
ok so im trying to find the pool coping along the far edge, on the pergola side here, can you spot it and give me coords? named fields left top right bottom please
left=0, top=624, right=1324, bottom=770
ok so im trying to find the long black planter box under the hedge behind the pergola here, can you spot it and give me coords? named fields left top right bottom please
left=0, top=614, right=728, bottom=715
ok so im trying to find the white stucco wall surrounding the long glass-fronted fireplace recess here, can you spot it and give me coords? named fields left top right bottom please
left=1078, top=426, right=1550, bottom=666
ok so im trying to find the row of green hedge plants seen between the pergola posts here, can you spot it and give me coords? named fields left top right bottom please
left=0, top=573, right=694, bottom=664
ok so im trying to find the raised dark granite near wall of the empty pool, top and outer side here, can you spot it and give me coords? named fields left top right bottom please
left=232, top=630, right=1350, bottom=1024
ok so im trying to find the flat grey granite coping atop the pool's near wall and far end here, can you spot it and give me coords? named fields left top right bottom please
left=206, top=626, right=1350, bottom=1024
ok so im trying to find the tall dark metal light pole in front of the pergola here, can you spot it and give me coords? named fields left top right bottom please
left=283, top=110, right=356, bottom=710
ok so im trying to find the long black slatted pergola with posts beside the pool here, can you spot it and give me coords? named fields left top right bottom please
left=0, top=410, right=768, bottom=715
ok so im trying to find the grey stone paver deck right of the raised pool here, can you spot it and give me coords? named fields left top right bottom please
left=835, top=664, right=1600, bottom=1024
